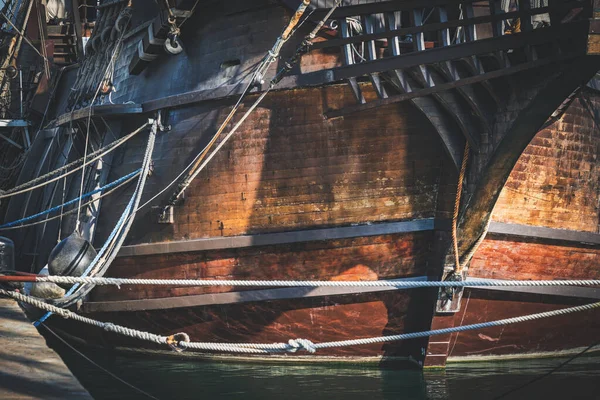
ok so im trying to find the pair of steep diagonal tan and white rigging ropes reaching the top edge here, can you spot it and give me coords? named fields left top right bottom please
left=164, top=0, right=341, bottom=213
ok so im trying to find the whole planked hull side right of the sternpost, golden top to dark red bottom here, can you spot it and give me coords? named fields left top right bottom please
left=426, top=89, right=600, bottom=365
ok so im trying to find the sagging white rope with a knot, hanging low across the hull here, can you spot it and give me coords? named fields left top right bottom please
left=0, top=289, right=600, bottom=354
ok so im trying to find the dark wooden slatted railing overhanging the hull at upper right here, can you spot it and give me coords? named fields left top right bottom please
left=304, top=0, right=593, bottom=117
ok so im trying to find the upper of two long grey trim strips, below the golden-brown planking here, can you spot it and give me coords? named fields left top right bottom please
left=118, top=218, right=438, bottom=257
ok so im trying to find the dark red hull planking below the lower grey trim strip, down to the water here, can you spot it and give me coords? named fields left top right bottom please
left=59, top=291, right=428, bottom=362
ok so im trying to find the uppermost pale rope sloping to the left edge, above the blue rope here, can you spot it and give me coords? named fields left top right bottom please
left=0, top=122, right=149, bottom=199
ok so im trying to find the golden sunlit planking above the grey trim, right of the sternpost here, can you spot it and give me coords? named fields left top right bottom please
left=494, top=89, right=600, bottom=232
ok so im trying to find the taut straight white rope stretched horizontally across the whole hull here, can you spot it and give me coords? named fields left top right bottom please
left=0, top=275, right=600, bottom=289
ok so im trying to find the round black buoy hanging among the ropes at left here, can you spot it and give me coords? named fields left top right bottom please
left=48, top=232, right=97, bottom=282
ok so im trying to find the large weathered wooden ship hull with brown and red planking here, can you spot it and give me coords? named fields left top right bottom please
left=0, top=0, right=600, bottom=367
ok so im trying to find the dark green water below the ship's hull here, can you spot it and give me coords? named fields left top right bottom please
left=48, top=334, right=600, bottom=400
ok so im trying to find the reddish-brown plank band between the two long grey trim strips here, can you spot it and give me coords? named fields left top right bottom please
left=91, top=232, right=433, bottom=301
